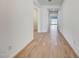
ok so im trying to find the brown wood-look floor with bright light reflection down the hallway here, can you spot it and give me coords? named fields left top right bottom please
left=16, top=27, right=77, bottom=58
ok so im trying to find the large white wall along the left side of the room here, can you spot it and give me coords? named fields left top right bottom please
left=0, top=0, right=33, bottom=57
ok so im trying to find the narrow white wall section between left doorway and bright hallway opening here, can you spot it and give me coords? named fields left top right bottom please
left=39, top=6, right=48, bottom=32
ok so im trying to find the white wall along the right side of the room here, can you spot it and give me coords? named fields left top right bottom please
left=59, top=0, right=79, bottom=56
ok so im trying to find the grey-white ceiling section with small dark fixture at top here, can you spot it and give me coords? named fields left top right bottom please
left=37, top=0, right=64, bottom=6
